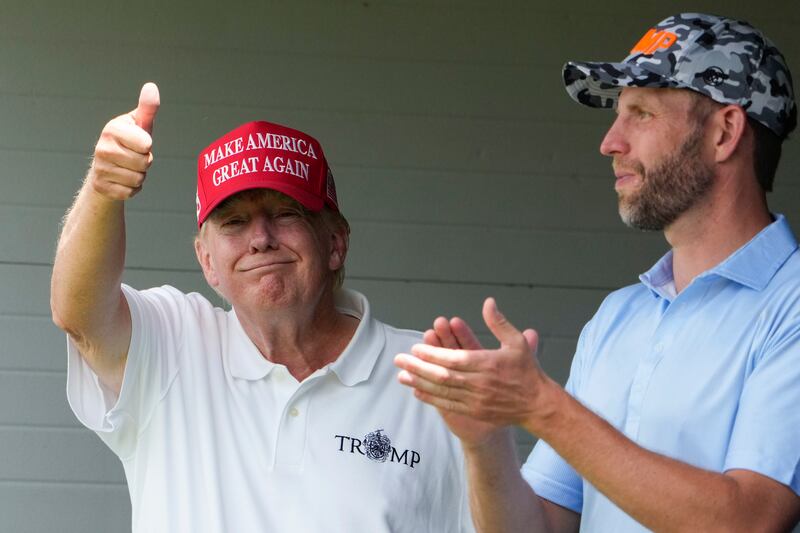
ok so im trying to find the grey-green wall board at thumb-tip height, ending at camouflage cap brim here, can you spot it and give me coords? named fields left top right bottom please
left=0, top=38, right=574, bottom=120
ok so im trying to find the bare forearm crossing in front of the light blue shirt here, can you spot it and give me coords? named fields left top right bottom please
left=525, top=389, right=791, bottom=531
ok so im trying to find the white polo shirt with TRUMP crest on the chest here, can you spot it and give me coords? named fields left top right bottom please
left=67, top=286, right=473, bottom=533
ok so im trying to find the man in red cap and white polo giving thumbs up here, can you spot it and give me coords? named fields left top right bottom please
left=52, top=84, right=472, bottom=533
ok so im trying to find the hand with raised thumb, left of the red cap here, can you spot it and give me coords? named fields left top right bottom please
left=87, top=83, right=160, bottom=200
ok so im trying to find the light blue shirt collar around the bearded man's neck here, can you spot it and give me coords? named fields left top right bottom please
left=639, top=214, right=797, bottom=300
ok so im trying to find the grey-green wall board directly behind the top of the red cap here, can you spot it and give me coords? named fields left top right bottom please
left=0, top=95, right=611, bottom=177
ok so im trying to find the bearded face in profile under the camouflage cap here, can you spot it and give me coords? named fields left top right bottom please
left=600, top=88, right=714, bottom=231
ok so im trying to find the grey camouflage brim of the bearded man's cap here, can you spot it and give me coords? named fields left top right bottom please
left=563, top=61, right=681, bottom=108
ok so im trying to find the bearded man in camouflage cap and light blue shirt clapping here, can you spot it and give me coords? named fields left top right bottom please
left=397, top=14, right=800, bottom=532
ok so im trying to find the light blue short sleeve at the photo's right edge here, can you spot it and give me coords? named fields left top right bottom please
left=725, top=320, right=800, bottom=494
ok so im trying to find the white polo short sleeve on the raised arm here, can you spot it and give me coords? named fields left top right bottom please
left=67, top=285, right=185, bottom=457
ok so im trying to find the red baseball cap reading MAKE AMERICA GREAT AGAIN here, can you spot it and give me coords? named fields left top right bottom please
left=197, top=121, right=339, bottom=227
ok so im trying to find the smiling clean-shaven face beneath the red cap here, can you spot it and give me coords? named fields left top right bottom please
left=195, top=189, right=346, bottom=312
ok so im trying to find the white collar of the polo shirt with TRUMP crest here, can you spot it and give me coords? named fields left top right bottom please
left=228, top=289, right=386, bottom=387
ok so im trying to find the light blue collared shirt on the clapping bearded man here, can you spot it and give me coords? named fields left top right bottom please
left=522, top=215, right=800, bottom=532
